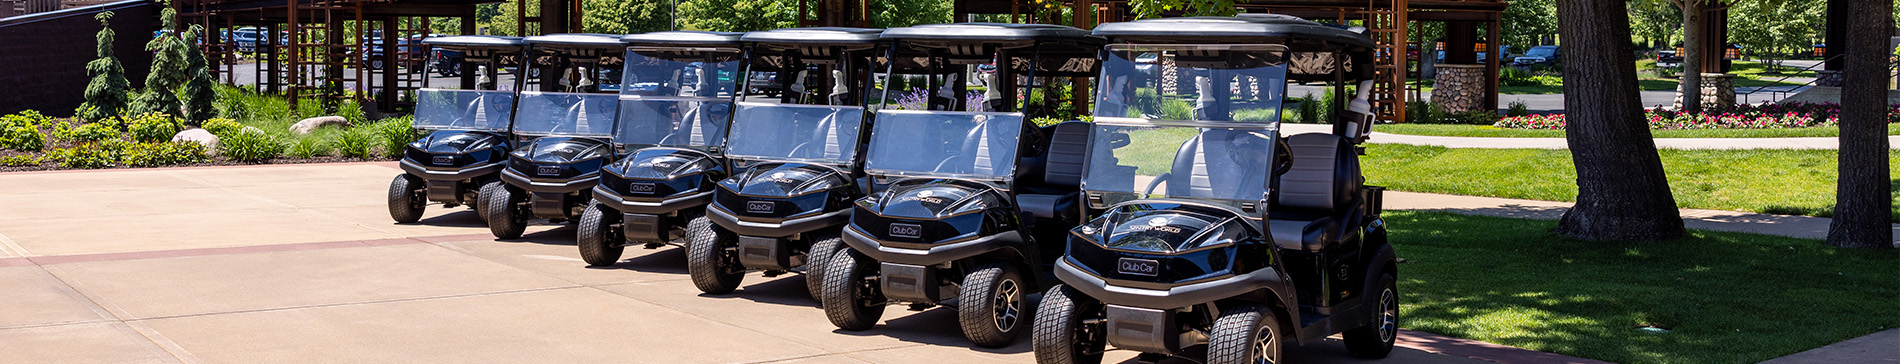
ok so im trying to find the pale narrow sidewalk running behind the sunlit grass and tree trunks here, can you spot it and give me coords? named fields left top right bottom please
left=1281, top=123, right=1900, bottom=150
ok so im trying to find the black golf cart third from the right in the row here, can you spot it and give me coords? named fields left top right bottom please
left=686, top=28, right=880, bottom=298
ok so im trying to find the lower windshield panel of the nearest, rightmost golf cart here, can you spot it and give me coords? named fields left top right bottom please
left=1083, top=119, right=1279, bottom=207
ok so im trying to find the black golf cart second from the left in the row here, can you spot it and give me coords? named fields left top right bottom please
left=481, top=34, right=627, bottom=239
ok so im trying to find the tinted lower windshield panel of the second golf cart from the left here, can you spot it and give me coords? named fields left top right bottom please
left=515, top=91, right=616, bottom=137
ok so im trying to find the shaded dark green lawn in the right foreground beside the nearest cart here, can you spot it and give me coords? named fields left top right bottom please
left=1385, top=212, right=1900, bottom=364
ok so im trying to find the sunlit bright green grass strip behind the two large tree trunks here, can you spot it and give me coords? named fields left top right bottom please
left=1360, top=144, right=1900, bottom=218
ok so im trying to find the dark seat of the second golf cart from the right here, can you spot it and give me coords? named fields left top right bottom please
left=1017, top=121, right=1093, bottom=222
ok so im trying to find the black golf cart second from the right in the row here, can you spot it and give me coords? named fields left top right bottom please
left=821, top=23, right=1106, bottom=347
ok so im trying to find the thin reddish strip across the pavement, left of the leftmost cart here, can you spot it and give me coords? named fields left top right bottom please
left=18, top=235, right=494, bottom=267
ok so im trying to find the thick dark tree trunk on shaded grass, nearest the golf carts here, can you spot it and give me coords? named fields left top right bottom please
left=1556, top=0, right=1689, bottom=241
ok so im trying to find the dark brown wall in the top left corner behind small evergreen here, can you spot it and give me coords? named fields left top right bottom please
left=0, top=0, right=158, bottom=116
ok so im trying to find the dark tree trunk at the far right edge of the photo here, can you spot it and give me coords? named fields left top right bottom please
left=1828, top=0, right=1894, bottom=248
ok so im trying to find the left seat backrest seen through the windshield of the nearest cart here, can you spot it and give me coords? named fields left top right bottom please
left=1167, top=129, right=1273, bottom=201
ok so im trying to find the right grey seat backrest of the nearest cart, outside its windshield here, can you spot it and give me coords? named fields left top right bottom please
left=1279, top=133, right=1360, bottom=214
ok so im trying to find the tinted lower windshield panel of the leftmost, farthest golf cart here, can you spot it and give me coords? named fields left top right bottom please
left=414, top=89, right=515, bottom=131
